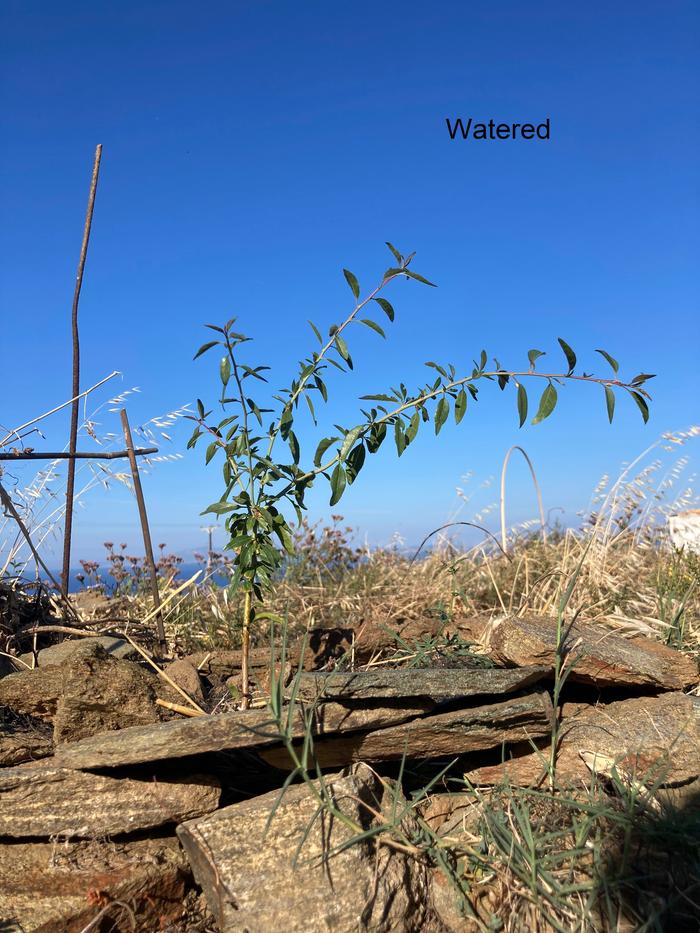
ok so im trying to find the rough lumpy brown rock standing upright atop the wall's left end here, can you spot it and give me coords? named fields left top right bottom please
left=53, top=644, right=160, bottom=745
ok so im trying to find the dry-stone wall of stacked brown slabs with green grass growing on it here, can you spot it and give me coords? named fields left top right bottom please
left=0, top=593, right=700, bottom=933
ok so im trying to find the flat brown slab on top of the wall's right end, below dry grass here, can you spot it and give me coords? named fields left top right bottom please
left=487, top=616, right=698, bottom=690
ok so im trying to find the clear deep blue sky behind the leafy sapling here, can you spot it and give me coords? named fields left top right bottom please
left=0, top=0, right=700, bottom=557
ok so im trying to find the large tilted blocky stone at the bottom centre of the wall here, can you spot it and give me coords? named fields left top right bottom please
left=177, top=765, right=432, bottom=933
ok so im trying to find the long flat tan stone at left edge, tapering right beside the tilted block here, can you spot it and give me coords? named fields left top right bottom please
left=0, top=765, right=221, bottom=839
